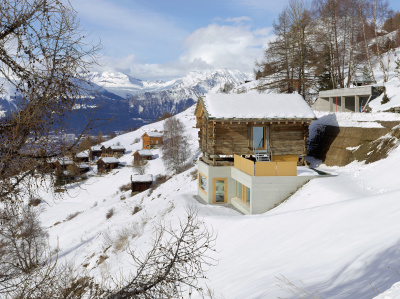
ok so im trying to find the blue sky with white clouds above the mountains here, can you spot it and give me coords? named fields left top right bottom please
left=70, top=0, right=400, bottom=80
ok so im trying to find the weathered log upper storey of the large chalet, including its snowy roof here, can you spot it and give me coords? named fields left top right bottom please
left=196, top=94, right=315, bottom=165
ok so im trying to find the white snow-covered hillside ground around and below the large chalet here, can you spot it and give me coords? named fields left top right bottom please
left=34, top=107, right=400, bottom=299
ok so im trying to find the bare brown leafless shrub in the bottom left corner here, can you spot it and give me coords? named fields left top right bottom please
left=0, top=206, right=99, bottom=298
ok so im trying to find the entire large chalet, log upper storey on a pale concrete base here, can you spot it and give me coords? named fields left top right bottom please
left=195, top=93, right=316, bottom=214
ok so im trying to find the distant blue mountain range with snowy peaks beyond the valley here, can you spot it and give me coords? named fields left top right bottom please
left=0, top=69, right=248, bottom=133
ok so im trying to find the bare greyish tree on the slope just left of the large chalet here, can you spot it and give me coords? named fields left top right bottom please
left=161, top=116, right=190, bottom=171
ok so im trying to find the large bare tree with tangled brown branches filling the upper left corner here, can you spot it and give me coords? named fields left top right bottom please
left=0, top=0, right=98, bottom=206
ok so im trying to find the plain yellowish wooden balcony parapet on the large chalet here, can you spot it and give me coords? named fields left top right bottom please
left=234, top=155, right=297, bottom=176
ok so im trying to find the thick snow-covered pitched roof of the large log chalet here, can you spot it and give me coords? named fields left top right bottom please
left=200, top=93, right=316, bottom=120
